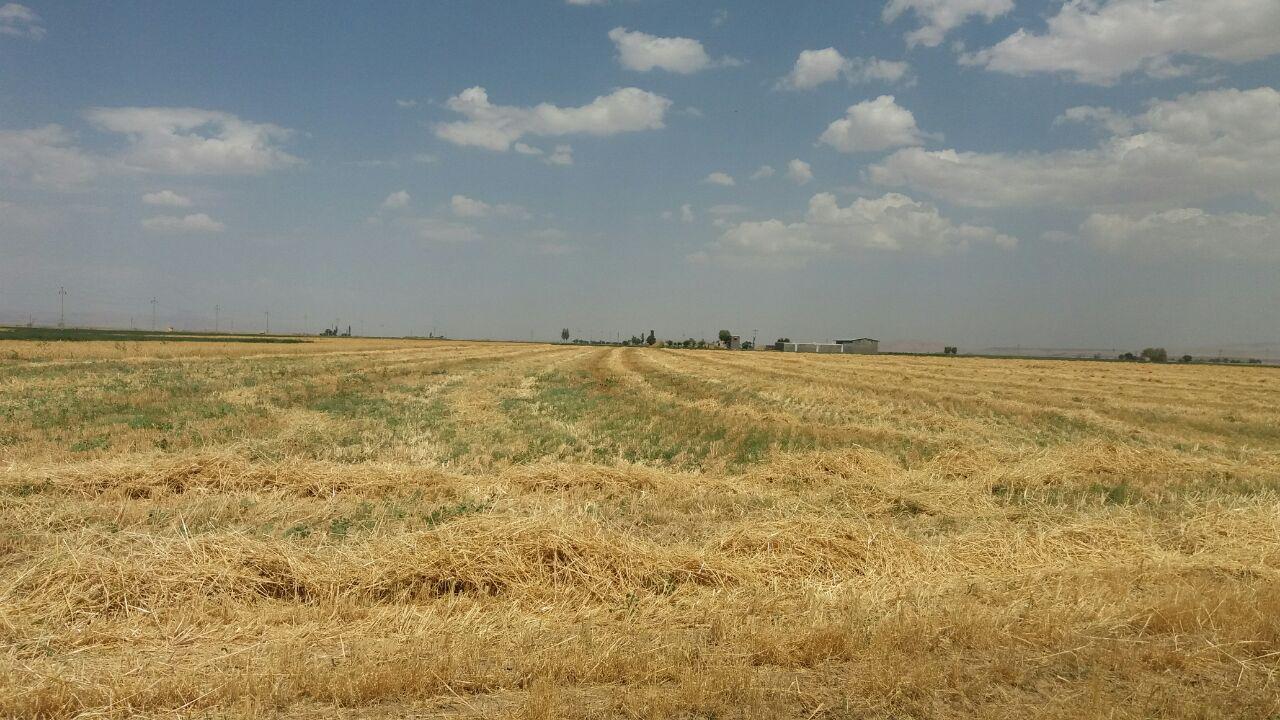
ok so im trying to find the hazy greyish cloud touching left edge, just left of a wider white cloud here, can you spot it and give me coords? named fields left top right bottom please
left=0, top=126, right=102, bottom=188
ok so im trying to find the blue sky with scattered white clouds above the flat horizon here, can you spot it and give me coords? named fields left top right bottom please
left=0, top=0, right=1280, bottom=350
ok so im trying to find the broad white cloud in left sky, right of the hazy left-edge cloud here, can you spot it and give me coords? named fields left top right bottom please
left=87, top=108, right=301, bottom=176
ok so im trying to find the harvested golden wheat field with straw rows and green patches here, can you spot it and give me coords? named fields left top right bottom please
left=0, top=340, right=1280, bottom=719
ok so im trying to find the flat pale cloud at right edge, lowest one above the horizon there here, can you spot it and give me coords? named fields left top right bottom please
left=1080, top=208, right=1280, bottom=260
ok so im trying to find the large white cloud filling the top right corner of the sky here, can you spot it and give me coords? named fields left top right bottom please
left=963, top=0, right=1280, bottom=85
